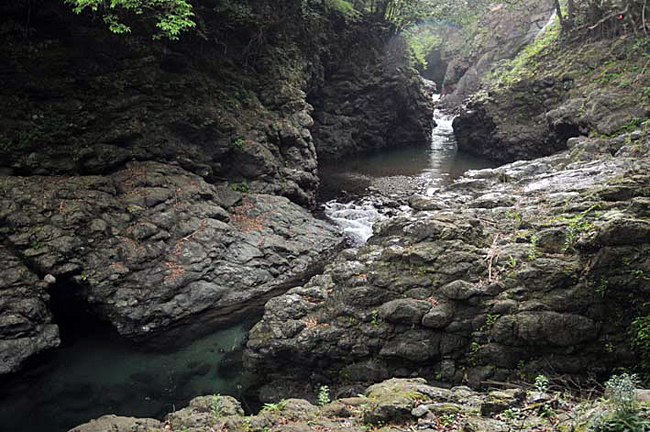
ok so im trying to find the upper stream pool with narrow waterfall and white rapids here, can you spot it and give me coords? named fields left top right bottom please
left=319, top=107, right=495, bottom=244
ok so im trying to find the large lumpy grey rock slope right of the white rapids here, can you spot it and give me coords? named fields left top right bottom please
left=247, top=134, right=650, bottom=386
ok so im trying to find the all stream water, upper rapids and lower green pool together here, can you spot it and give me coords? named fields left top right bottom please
left=0, top=107, right=489, bottom=432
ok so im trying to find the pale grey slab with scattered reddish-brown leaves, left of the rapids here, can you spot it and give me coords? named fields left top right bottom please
left=0, top=162, right=341, bottom=364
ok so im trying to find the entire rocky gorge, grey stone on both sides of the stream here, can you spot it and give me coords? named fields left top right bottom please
left=0, top=2, right=650, bottom=432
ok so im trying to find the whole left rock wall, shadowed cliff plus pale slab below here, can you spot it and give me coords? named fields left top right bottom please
left=0, top=1, right=431, bottom=373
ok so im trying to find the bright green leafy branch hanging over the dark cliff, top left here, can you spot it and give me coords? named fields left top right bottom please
left=65, top=0, right=196, bottom=40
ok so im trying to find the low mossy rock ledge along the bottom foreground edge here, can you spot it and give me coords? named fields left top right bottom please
left=70, top=378, right=650, bottom=432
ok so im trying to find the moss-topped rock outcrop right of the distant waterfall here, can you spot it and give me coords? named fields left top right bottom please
left=453, top=35, right=650, bottom=163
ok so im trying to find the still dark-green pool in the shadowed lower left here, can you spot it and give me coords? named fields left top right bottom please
left=0, top=310, right=252, bottom=432
